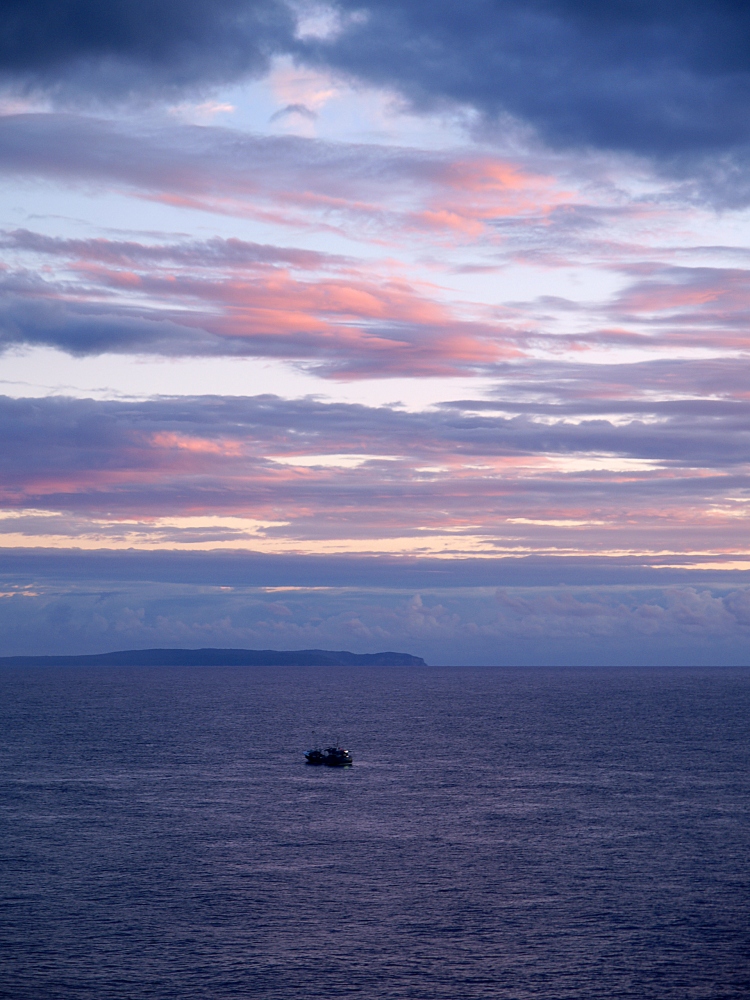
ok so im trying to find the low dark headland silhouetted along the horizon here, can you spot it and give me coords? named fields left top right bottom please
left=0, top=649, right=427, bottom=667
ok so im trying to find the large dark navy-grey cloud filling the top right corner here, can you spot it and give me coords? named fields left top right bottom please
left=314, top=0, right=750, bottom=158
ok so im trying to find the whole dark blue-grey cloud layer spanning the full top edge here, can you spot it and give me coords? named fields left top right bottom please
left=0, top=0, right=750, bottom=164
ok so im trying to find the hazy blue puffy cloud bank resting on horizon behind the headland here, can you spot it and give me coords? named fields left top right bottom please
left=0, top=573, right=750, bottom=666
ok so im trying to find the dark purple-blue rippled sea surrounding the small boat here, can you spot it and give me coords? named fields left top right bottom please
left=0, top=668, right=750, bottom=1000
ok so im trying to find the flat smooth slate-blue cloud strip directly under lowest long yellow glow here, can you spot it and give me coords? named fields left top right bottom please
left=0, top=547, right=750, bottom=592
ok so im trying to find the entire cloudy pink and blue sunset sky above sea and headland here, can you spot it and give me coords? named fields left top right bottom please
left=0, top=0, right=750, bottom=665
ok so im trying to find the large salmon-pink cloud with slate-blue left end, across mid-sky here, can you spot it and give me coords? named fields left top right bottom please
left=0, top=254, right=520, bottom=378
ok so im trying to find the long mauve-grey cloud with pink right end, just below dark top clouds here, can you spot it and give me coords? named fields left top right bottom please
left=0, top=113, right=569, bottom=238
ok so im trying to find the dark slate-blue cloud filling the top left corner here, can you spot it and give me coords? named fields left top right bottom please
left=0, top=0, right=295, bottom=97
